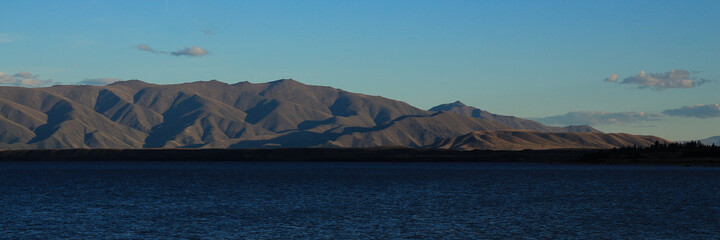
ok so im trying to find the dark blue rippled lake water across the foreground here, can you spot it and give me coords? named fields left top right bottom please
left=0, top=162, right=720, bottom=239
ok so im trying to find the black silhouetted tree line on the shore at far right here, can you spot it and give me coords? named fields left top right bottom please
left=583, top=141, right=720, bottom=161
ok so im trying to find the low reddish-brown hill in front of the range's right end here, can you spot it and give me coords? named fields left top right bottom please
left=427, top=130, right=670, bottom=150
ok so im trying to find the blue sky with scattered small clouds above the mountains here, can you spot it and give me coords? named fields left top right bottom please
left=0, top=0, right=720, bottom=140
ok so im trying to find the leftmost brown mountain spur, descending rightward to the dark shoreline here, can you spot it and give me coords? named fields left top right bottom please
left=0, top=87, right=145, bottom=149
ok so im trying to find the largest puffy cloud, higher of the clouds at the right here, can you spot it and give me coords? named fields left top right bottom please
left=605, top=69, right=710, bottom=91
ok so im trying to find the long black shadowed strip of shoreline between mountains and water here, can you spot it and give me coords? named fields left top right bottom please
left=0, top=148, right=720, bottom=166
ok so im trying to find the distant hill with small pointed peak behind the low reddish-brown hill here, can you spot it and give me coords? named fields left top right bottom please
left=429, top=101, right=600, bottom=132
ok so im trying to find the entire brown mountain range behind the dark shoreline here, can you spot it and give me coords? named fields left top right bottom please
left=0, top=79, right=667, bottom=150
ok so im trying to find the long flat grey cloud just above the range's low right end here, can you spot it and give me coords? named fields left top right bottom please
left=533, top=111, right=663, bottom=126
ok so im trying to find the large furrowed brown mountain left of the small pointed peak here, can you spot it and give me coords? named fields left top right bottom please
left=0, top=80, right=436, bottom=149
